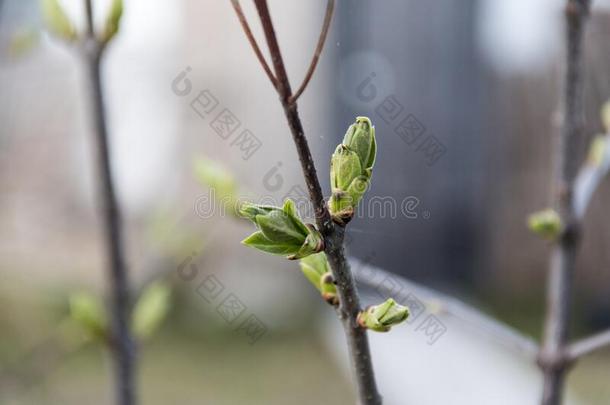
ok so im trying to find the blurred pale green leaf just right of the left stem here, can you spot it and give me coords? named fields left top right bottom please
left=132, top=281, right=171, bottom=339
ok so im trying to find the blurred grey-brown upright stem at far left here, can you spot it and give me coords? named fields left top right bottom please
left=82, top=0, right=135, bottom=405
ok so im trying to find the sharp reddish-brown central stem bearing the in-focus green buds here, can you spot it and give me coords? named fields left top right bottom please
left=235, top=0, right=382, bottom=405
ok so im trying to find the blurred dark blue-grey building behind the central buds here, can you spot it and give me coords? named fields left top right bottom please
left=335, top=1, right=490, bottom=290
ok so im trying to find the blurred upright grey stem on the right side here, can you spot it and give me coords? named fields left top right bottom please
left=538, top=0, right=589, bottom=405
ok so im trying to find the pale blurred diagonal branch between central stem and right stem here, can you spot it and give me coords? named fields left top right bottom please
left=350, top=259, right=538, bottom=360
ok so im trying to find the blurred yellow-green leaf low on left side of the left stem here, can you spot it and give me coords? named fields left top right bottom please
left=69, top=292, right=108, bottom=339
